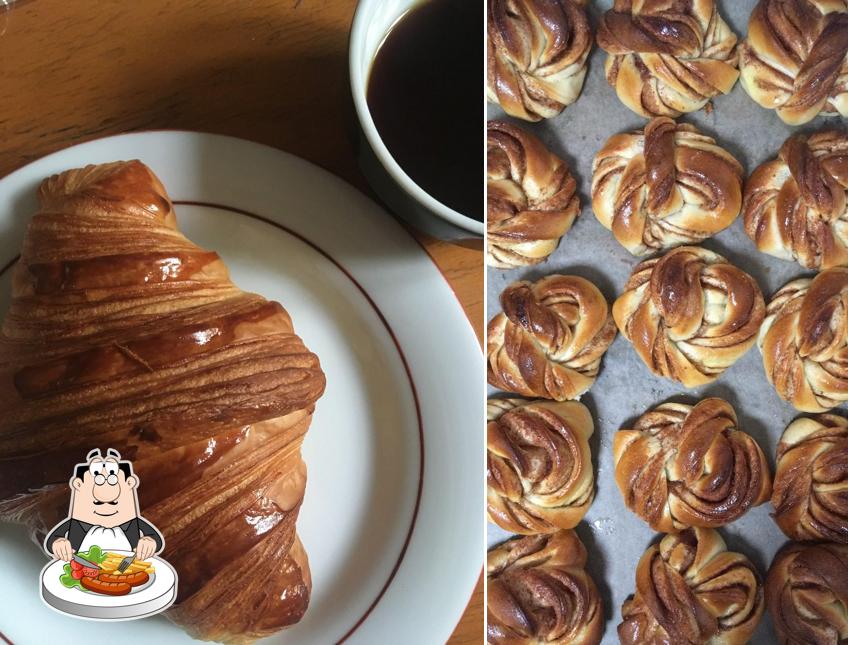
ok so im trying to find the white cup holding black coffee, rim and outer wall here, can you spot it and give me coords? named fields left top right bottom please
left=348, top=0, right=483, bottom=240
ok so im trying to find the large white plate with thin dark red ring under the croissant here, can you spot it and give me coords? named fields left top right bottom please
left=0, top=132, right=484, bottom=645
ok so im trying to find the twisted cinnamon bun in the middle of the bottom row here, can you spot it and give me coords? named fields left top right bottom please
left=618, top=528, right=764, bottom=645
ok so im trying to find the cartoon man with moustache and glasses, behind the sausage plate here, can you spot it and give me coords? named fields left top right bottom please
left=44, top=448, right=165, bottom=562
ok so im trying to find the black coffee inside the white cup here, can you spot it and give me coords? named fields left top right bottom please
left=368, top=0, right=484, bottom=221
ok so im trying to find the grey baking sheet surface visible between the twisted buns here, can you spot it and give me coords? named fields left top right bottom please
left=487, top=0, right=844, bottom=645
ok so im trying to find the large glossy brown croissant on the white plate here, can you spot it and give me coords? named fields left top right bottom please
left=0, top=161, right=324, bottom=643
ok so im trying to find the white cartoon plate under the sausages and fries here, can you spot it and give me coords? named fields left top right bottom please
left=41, top=551, right=177, bottom=620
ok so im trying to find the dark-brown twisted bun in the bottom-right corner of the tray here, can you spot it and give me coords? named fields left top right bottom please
left=765, top=542, right=848, bottom=645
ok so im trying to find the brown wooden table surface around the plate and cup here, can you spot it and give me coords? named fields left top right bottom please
left=0, top=0, right=483, bottom=644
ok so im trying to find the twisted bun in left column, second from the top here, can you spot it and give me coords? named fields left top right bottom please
left=486, top=121, right=580, bottom=269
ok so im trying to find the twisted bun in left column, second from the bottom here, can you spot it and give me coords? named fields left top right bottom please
left=486, top=399, right=595, bottom=535
